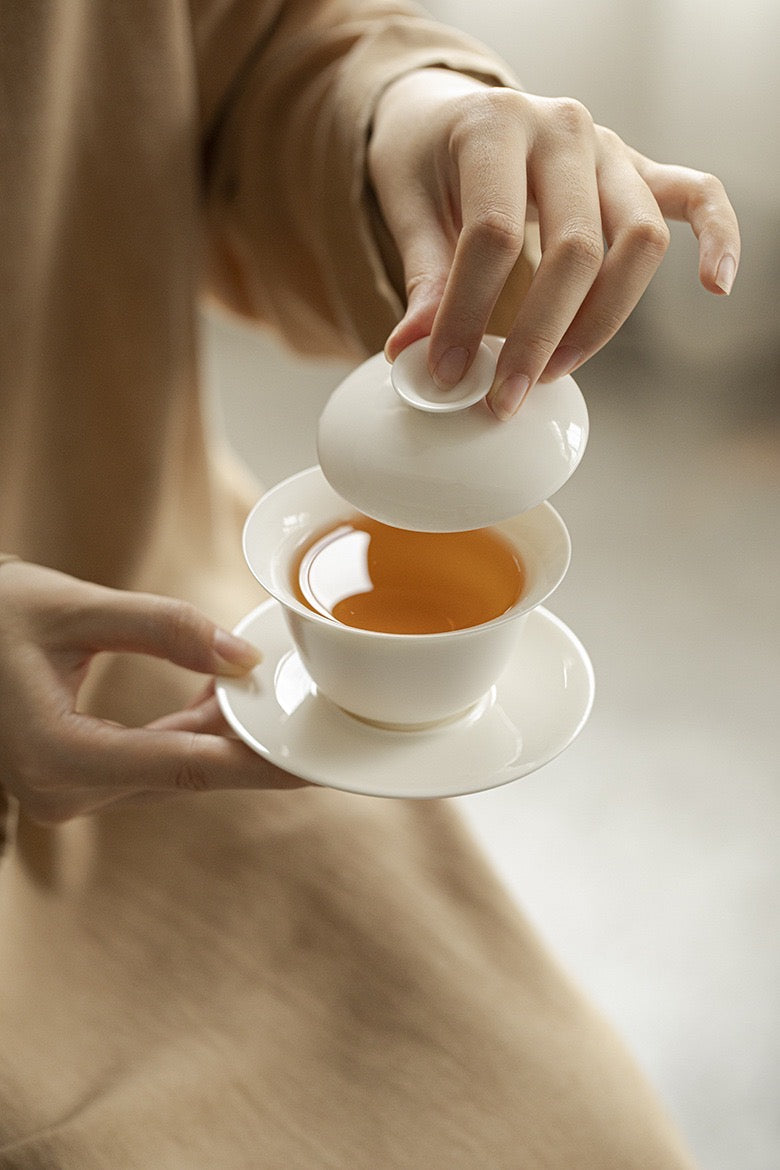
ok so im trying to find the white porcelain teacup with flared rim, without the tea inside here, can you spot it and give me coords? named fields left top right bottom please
left=243, top=467, right=571, bottom=725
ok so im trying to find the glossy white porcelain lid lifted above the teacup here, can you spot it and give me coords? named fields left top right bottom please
left=317, top=338, right=588, bottom=531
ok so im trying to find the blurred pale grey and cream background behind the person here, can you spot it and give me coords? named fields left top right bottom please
left=203, top=0, right=780, bottom=1170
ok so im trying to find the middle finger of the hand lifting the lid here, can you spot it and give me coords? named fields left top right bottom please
left=488, top=101, right=603, bottom=419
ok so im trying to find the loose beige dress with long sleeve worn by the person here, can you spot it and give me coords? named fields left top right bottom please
left=0, top=0, right=690, bottom=1170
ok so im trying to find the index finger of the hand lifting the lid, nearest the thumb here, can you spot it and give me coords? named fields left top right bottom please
left=429, top=90, right=526, bottom=390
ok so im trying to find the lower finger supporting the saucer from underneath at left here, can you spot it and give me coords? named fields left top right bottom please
left=61, top=716, right=305, bottom=792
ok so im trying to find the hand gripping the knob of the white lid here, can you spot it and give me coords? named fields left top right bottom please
left=368, top=69, right=739, bottom=419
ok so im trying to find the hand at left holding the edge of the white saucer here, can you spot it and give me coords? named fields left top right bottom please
left=0, top=562, right=303, bottom=823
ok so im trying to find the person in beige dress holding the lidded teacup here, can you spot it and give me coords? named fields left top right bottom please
left=0, top=0, right=739, bottom=1170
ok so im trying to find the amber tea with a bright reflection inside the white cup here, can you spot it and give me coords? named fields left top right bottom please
left=291, top=516, right=525, bottom=634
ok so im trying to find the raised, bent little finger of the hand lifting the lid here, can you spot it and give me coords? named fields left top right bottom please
left=631, top=151, right=740, bottom=295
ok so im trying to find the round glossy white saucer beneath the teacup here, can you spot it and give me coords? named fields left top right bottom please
left=216, top=601, right=594, bottom=798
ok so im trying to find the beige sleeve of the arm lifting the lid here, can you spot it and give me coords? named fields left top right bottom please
left=195, top=0, right=517, bottom=358
